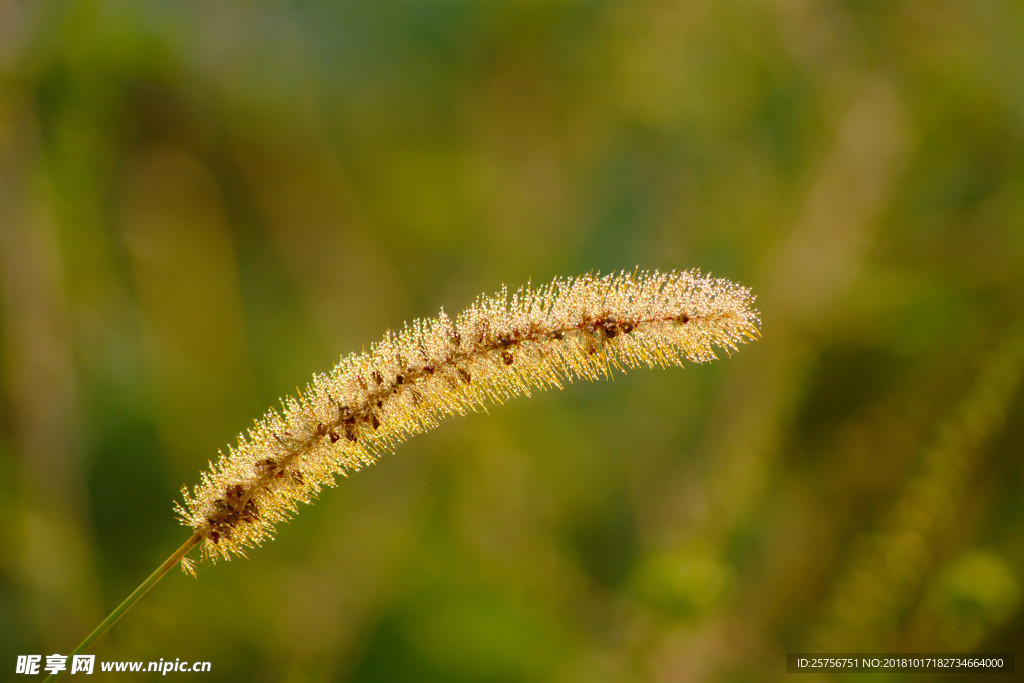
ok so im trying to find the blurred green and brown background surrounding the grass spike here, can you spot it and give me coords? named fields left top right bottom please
left=0, top=0, right=1024, bottom=682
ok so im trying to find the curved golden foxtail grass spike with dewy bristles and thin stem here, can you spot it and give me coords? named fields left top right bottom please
left=51, top=270, right=760, bottom=679
